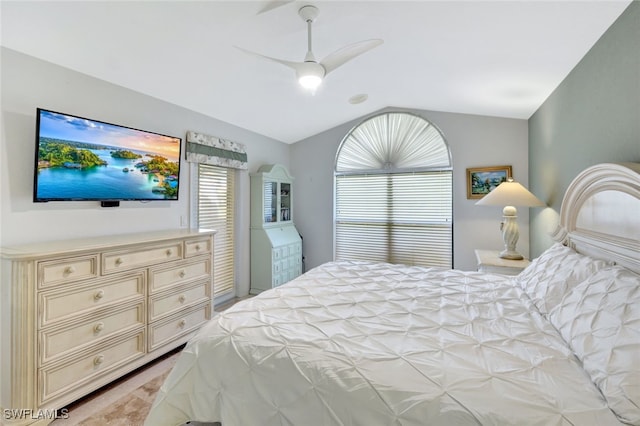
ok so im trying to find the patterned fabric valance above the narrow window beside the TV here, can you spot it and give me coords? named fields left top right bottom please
left=186, top=130, right=248, bottom=170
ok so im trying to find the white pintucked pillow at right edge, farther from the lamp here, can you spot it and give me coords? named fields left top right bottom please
left=549, top=266, right=640, bottom=425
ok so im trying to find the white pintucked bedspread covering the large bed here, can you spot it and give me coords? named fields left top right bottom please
left=146, top=262, right=620, bottom=426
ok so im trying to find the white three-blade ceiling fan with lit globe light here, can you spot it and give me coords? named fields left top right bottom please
left=236, top=5, right=383, bottom=93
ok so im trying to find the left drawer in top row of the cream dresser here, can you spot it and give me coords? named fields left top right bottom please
left=38, top=255, right=98, bottom=288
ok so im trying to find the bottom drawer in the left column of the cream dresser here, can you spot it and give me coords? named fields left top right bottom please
left=38, top=329, right=145, bottom=405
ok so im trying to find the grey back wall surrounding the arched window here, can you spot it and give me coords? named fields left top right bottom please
left=290, top=108, right=529, bottom=270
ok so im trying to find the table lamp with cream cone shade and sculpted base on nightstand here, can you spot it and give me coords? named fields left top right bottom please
left=476, top=178, right=546, bottom=260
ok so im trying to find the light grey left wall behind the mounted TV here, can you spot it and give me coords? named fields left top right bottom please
left=0, top=48, right=289, bottom=294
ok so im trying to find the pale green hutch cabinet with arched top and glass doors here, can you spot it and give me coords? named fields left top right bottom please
left=250, top=164, right=302, bottom=294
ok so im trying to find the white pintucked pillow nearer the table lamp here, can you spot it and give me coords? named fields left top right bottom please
left=516, top=243, right=607, bottom=316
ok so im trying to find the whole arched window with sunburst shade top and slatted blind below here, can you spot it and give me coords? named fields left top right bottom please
left=334, top=112, right=453, bottom=268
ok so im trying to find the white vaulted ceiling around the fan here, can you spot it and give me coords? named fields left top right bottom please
left=0, top=0, right=630, bottom=143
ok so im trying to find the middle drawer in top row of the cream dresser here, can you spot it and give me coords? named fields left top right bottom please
left=102, top=241, right=182, bottom=274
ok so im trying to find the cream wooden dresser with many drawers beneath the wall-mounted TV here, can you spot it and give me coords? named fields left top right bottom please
left=0, top=230, right=214, bottom=424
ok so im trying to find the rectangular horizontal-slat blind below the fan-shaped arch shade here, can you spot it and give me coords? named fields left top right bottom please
left=335, top=170, right=453, bottom=268
